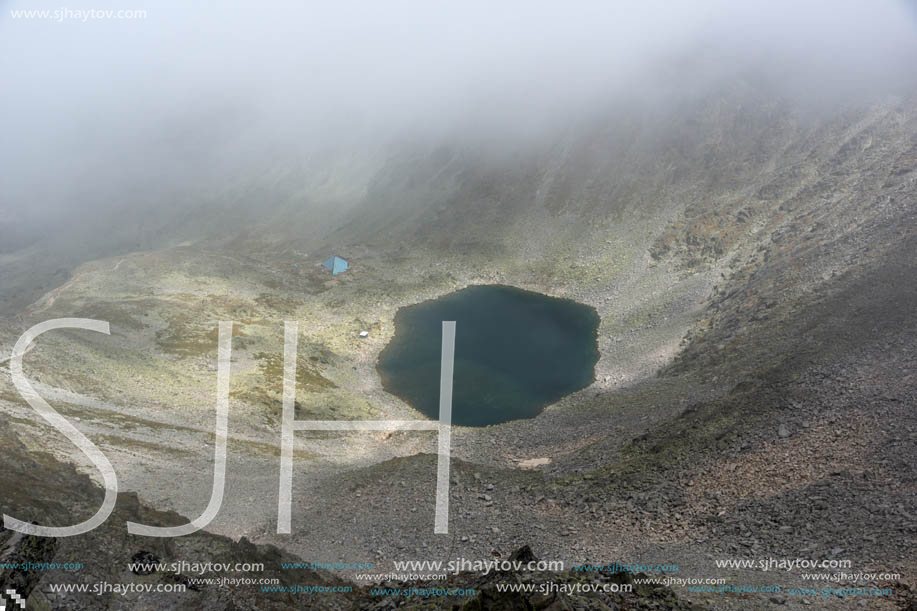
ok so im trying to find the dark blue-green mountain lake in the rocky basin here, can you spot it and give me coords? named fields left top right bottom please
left=378, top=285, right=599, bottom=426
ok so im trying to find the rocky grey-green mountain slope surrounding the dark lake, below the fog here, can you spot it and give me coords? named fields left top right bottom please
left=0, top=81, right=917, bottom=609
